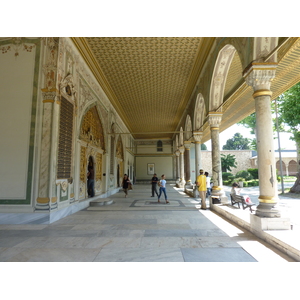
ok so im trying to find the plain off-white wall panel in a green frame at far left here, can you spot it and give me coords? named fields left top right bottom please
left=0, top=50, right=35, bottom=199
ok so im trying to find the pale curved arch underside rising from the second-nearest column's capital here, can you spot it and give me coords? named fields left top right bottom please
left=209, top=44, right=236, bottom=111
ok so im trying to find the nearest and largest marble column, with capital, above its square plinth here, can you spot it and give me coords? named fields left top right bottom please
left=243, top=63, right=280, bottom=218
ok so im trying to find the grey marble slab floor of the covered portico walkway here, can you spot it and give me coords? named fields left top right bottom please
left=0, top=185, right=294, bottom=263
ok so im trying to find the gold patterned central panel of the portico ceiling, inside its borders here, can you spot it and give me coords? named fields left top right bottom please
left=86, top=37, right=211, bottom=138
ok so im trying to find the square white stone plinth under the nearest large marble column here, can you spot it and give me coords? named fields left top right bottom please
left=250, top=214, right=291, bottom=231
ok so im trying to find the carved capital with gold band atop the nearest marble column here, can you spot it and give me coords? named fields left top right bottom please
left=243, top=62, right=277, bottom=91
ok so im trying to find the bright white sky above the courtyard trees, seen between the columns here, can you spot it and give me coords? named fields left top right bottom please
left=205, top=124, right=296, bottom=150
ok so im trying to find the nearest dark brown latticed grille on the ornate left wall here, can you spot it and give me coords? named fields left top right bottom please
left=57, top=97, right=74, bottom=179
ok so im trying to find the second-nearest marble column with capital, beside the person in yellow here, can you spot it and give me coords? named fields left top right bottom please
left=208, top=112, right=228, bottom=203
